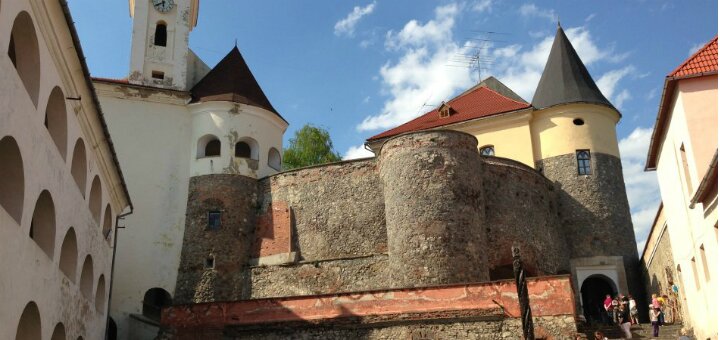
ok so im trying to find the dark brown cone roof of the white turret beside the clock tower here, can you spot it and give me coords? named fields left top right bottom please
left=190, top=46, right=287, bottom=122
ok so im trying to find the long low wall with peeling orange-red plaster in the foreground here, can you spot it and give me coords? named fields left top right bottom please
left=162, top=276, right=576, bottom=339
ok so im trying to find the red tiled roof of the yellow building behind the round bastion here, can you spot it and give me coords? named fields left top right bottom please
left=368, top=86, right=530, bottom=141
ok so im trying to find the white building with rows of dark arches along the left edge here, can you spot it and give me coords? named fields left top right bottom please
left=0, top=0, right=132, bottom=340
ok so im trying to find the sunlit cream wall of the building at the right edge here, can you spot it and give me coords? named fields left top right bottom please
left=657, top=85, right=718, bottom=339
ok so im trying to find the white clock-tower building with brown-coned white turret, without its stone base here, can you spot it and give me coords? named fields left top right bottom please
left=94, top=0, right=288, bottom=339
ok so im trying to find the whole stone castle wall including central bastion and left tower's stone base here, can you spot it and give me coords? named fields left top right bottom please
left=174, top=131, right=568, bottom=303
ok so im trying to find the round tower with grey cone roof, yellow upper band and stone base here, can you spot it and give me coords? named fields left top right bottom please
left=531, top=26, right=639, bottom=318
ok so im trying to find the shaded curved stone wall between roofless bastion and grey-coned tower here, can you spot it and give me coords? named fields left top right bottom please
left=482, top=157, right=570, bottom=279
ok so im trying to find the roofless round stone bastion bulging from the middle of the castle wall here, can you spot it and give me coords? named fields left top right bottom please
left=378, top=131, right=489, bottom=287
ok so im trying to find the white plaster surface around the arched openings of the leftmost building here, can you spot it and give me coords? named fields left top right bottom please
left=0, top=0, right=127, bottom=339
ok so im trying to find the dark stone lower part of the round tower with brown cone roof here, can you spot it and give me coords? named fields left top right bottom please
left=173, top=175, right=258, bottom=303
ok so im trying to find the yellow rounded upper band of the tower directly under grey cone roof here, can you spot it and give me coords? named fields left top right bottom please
left=530, top=104, right=620, bottom=160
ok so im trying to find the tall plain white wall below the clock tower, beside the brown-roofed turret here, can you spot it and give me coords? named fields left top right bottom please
left=95, top=82, right=193, bottom=339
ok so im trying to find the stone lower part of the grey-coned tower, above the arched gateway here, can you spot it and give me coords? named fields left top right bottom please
left=537, top=153, right=643, bottom=296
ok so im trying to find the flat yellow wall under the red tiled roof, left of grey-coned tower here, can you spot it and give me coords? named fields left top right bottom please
left=452, top=110, right=535, bottom=168
